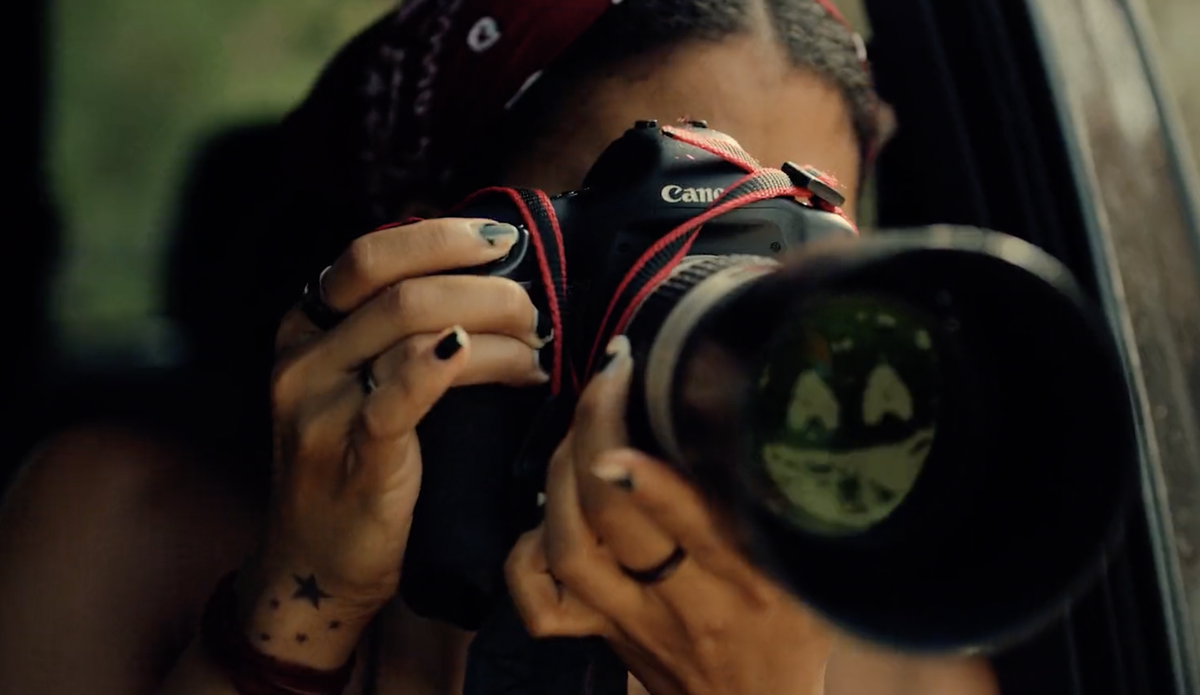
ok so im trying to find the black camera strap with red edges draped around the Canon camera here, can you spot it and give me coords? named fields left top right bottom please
left=463, top=126, right=852, bottom=695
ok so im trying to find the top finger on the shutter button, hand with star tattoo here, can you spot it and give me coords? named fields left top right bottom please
left=322, top=218, right=517, bottom=313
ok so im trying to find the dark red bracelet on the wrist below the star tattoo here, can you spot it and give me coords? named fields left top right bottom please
left=200, top=573, right=354, bottom=695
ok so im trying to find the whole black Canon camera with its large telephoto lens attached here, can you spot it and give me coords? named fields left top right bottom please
left=401, top=121, right=1135, bottom=651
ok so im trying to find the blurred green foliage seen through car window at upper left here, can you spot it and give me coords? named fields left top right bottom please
left=49, top=0, right=395, bottom=348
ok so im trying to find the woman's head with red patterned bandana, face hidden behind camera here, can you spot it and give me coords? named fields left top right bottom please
left=283, top=0, right=878, bottom=223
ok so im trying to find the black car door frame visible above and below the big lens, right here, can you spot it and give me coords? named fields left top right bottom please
left=868, top=0, right=1181, bottom=695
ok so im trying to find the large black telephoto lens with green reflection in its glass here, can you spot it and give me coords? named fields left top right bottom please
left=628, top=227, right=1135, bottom=652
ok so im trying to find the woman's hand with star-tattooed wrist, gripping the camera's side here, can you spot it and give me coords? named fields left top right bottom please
left=240, top=218, right=548, bottom=669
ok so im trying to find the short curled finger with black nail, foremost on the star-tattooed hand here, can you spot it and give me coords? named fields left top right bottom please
left=361, top=326, right=470, bottom=442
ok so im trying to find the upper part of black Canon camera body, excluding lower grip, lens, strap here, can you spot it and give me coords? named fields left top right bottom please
left=454, top=121, right=858, bottom=367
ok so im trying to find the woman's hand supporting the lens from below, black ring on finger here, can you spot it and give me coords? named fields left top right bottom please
left=505, top=337, right=994, bottom=695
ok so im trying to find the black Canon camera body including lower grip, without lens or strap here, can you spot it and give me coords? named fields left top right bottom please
left=401, top=121, right=857, bottom=629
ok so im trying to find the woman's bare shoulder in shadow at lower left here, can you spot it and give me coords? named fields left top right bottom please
left=0, top=426, right=265, bottom=695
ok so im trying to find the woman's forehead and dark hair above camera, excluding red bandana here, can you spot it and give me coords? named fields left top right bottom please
left=489, top=0, right=878, bottom=217
